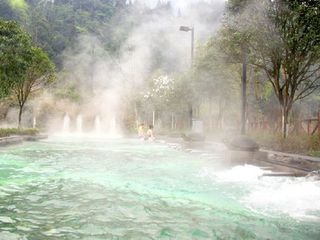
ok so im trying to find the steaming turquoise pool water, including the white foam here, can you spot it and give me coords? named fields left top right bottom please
left=0, top=138, right=320, bottom=240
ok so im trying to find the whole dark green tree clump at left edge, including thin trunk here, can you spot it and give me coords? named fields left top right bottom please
left=0, top=20, right=54, bottom=127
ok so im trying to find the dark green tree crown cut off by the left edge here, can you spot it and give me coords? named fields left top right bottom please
left=0, top=20, right=32, bottom=97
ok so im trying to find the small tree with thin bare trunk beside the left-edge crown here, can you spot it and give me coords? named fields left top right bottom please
left=13, top=47, right=54, bottom=128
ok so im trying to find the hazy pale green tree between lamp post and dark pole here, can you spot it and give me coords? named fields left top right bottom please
left=193, top=36, right=239, bottom=130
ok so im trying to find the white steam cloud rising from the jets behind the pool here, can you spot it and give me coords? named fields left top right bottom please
left=42, top=0, right=224, bottom=134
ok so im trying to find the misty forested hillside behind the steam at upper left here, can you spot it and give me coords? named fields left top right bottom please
left=0, top=0, right=178, bottom=74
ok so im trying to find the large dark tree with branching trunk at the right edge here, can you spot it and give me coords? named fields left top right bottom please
left=221, top=0, right=320, bottom=137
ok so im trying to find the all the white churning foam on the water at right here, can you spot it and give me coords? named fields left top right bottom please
left=199, top=165, right=320, bottom=222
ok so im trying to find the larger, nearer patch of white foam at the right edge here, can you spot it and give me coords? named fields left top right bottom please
left=243, top=178, right=320, bottom=221
